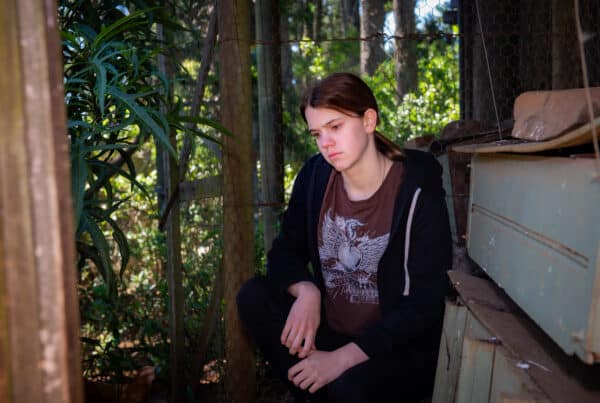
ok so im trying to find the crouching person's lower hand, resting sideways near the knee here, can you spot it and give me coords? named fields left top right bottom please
left=288, top=343, right=369, bottom=393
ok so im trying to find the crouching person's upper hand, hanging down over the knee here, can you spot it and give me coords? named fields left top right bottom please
left=281, top=281, right=321, bottom=358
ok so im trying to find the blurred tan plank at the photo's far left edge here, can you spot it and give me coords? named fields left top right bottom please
left=0, top=1, right=43, bottom=402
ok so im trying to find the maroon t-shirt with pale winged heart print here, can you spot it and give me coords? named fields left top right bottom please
left=318, top=162, right=404, bottom=336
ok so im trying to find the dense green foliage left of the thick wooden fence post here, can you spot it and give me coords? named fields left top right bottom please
left=59, top=0, right=229, bottom=390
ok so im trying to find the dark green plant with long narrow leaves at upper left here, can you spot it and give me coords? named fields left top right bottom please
left=61, top=5, right=175, bottom=295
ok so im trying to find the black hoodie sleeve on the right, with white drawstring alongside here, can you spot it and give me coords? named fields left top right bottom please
left=356, top=155, right=452, bottom=357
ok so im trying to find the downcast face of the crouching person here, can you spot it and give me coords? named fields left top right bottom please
left=304, top=106, right=377, bottom=172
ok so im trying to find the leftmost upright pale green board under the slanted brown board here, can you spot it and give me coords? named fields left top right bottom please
left=432, top=301, right=467, bottom=403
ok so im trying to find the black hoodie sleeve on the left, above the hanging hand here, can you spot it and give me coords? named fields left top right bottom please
left=267, top=162, right=314, bottom=291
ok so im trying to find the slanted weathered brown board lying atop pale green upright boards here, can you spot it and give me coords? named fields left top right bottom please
left=449, top=271, right=600, bottom=403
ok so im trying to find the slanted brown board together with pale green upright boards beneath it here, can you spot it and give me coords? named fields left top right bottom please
left=432, top=271, right=600, bottom=403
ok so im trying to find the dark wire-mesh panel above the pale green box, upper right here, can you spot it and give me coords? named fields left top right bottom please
left=460, top=0, right=600, bottom=128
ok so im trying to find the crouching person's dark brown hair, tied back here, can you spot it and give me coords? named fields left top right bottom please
left=300, top=73, right=404, bottom=160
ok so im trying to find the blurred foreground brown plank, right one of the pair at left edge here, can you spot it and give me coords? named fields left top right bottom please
left=17, top=0, right=81, bottom=402
